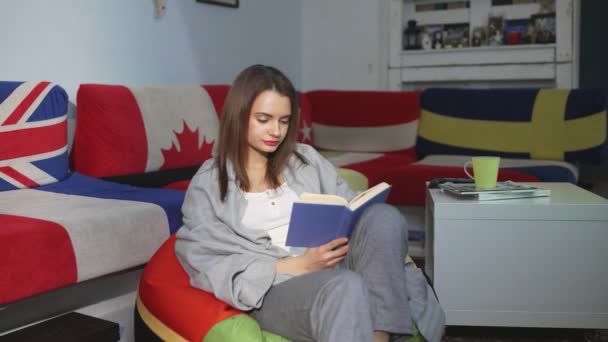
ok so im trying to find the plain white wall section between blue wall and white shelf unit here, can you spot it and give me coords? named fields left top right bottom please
left=302, top=0, right=389, bottom=90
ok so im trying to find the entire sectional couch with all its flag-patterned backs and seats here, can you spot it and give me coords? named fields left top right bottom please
left=0, top=82, right=607, bottom=340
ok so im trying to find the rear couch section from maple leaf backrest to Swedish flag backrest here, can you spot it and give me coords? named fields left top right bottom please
left=72, top=84, right=606, bottom=230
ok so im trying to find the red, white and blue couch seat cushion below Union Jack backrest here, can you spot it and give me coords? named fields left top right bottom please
left=0, top=174, right=184, bottom=303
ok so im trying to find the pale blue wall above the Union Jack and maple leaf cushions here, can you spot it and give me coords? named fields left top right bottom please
left=0, top=0, right=301, bottom=102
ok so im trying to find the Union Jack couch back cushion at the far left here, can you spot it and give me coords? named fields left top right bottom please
left=0, top=82, right=68, bottom=191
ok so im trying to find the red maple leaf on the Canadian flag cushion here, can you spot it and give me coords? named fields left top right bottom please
left=160, top=121, right=214, bottom=170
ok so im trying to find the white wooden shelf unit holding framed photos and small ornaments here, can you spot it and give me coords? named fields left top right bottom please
left=388, top=0, right=580, bottom=90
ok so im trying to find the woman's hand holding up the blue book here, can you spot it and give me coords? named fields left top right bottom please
left=276, top=238, right=348, bottom=275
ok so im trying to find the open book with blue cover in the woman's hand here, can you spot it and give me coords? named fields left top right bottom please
left=286, top=182, right=391, bottom=247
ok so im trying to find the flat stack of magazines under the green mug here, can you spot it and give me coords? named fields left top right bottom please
left=439, top=181, right=551, bottom=201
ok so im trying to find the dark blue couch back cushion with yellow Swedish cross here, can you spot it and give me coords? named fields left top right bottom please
left=416, top=89, right=607, bottom=163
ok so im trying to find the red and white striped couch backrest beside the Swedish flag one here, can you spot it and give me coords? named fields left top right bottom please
left=306, top=90, right=420, bottom=156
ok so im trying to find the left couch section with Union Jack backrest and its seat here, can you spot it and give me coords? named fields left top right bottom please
left=0, top=82, right=184, bottom=332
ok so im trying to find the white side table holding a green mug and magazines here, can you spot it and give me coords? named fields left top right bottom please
left=425, top=183, right=608, bottom=329
